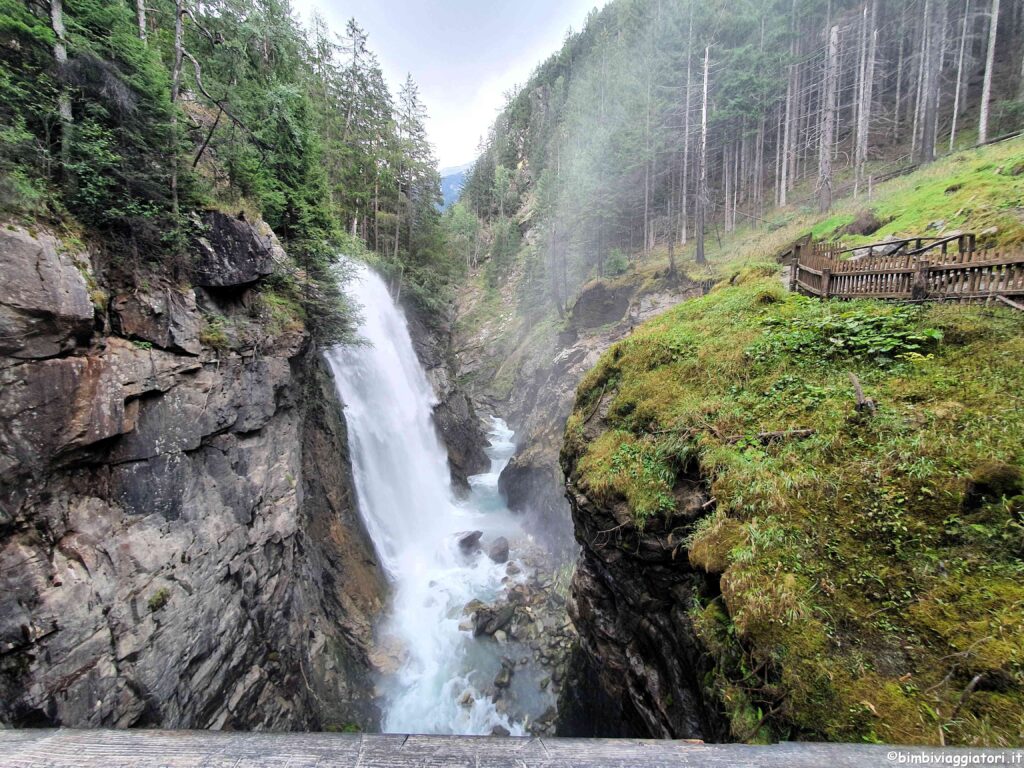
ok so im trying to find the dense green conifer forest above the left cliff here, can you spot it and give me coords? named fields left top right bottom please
left=0, top=0, right=451, bottom=341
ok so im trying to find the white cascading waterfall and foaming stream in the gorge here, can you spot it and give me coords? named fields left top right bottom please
left=328, top=265, right=544, bottom=735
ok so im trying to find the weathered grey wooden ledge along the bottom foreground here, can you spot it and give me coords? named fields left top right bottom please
left=0, top=729, right=1024, bottom=768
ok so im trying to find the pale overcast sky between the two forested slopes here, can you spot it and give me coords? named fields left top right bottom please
left=293, top=0, right=604, bottom=168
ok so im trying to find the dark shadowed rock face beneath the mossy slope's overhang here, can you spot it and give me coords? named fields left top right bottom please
left=562, top=394, right=728, bottom=741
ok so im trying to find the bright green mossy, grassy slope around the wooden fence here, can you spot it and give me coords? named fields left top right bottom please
left=566, top=141, right=1024, bottom=745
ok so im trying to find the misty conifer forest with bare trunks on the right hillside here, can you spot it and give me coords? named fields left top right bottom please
left=464, top=0, right=1024, bottom=315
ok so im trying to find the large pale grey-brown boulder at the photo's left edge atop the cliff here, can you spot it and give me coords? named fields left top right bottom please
left=0, top=227, right=93, bottom=365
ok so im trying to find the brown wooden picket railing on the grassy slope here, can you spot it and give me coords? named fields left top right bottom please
left=790, top=250, right=1024, bottom=301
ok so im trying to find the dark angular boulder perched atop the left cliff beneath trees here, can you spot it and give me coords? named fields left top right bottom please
left=193, top=211, right=280, bottom=288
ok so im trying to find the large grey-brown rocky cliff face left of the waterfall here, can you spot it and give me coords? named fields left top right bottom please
left=0, top=214, right=383, bottom=729
